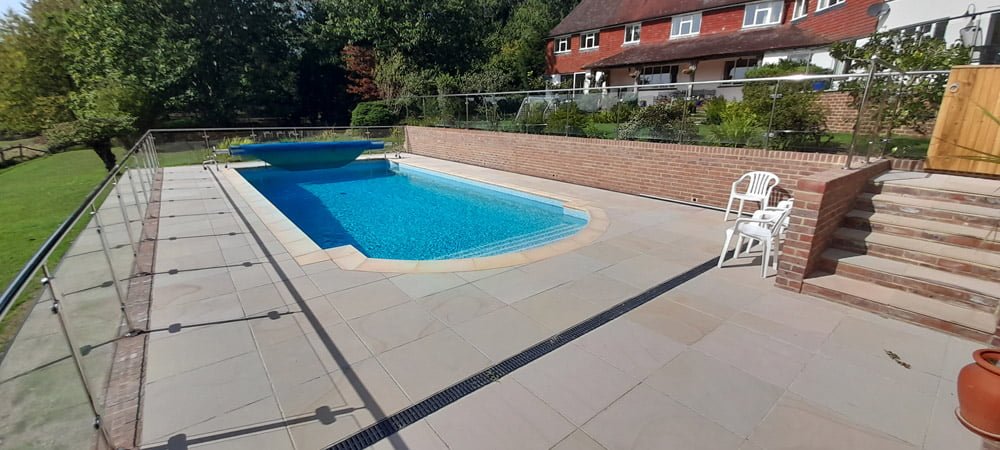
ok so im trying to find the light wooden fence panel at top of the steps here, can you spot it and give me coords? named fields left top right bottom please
left=927, top=66, right=1000, bottom=175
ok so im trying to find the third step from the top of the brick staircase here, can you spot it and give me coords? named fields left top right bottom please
left=844, top=209, right=1000, bottom=252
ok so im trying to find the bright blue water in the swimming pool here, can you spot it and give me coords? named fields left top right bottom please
left=240, top=160, right=587, bottom=260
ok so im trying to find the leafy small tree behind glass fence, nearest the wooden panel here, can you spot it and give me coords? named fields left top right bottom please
left=830, top=32, right=971, bottom=134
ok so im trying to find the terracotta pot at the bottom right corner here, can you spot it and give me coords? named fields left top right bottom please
left=956, top=349, right=1000, bottom=440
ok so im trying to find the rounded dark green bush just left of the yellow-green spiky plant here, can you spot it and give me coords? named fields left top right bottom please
left=618, top=100, right=698, bottom=142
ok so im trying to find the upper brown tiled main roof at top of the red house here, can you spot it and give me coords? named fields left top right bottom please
left=550, top=0, right=751, bottom=36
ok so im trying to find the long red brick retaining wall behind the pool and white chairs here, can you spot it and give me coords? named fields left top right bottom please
left=406, top=127, right=844, bottom=207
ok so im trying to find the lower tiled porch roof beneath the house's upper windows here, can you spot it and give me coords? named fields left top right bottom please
left=584, top=27, right=833, bottom=69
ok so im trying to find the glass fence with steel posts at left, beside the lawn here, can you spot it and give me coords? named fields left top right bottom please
left=0, top=134, right=157, bottom=449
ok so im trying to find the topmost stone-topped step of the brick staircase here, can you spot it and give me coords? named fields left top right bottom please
left=866, top=171, right=1000, bottom=208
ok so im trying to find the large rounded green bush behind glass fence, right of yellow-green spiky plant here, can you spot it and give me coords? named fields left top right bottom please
left=743, top=60, right=826, bottom=149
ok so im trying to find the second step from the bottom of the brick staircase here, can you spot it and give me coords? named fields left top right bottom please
left=820, top=249, right=1000, bottom=313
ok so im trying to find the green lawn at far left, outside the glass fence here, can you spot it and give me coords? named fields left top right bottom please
left=0, top=149, right=122, bottom=354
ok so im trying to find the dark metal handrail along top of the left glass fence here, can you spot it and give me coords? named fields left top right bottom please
left=0, top=131, right=150, bottom=320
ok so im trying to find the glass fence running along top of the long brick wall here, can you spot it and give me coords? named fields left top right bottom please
left=385, top=71, right=948, bottom=167
